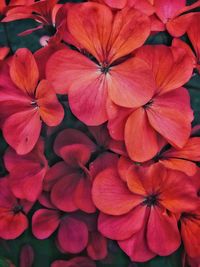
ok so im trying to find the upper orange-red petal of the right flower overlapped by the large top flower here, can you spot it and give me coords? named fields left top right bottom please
left=136, top=45, right=193, bottom=93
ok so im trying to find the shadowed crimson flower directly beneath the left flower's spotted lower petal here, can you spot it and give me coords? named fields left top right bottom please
left=4, top=139, right=48, bottom=202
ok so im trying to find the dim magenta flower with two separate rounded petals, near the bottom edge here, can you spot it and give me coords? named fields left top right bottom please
left=32, top=195, right=88, bottom=253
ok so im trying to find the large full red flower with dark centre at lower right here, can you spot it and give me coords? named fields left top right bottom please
left=92, top=163, right=198, bottom=261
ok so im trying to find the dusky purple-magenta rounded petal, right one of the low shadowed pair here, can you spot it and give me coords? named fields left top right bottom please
left=58, top=217, right=88, bottom=253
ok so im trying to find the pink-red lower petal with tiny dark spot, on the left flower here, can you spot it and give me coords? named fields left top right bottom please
left=2, top=109, right=41, bottom=155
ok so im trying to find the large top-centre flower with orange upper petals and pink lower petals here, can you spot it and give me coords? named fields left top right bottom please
left=46, top=2, right=155, bottom=126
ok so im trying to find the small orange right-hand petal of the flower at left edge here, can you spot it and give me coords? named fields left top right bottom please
left=35, top=80, right=64, bottom=126
